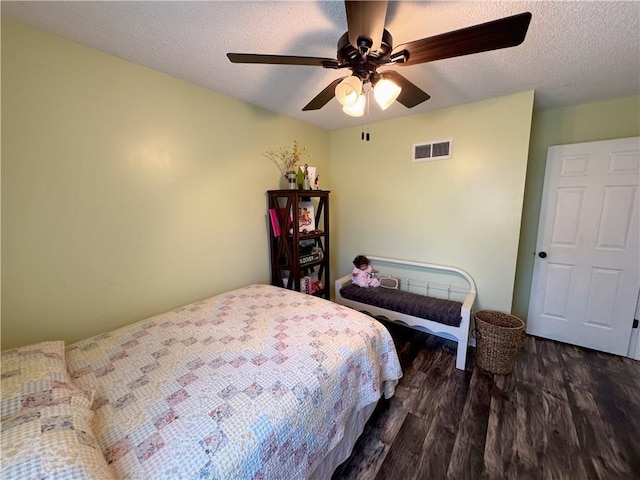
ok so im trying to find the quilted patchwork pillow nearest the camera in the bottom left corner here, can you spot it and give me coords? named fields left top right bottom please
left=0, top=396, right=114, bottom=480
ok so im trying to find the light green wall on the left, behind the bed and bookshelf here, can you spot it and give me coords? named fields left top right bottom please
left=2, top=18, right=330, bottom=349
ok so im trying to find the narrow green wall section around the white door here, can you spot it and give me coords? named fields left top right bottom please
left=512, top=96, right=640, bottom=320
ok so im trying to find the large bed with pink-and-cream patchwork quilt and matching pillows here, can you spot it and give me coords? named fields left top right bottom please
left=0, top=285, right=402, bottom=480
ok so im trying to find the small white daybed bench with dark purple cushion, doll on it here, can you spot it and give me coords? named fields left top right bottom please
left=335, top=256, right=476, bottom=370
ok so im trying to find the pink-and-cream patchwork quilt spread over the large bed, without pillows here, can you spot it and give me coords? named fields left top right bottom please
left=67, top=285, right=402, bottom=480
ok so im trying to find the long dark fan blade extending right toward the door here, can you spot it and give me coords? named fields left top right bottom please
left=391, top=12, right=531, bottom=66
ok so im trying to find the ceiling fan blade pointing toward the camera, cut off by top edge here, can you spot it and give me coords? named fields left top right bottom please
left=344, top=1, right=387, bottom=50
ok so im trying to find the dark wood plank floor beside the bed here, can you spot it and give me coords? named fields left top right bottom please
left=333, top=322, right=640, bottom=480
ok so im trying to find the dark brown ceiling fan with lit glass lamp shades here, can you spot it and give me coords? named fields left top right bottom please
left=227, top=1, right=531, bottom=116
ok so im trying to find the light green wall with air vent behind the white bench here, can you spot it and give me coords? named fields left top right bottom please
left=330, top=92, right=534, bottom=311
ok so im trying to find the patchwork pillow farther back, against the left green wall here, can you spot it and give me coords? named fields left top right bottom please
left=0, top=341, right=92, bottom=420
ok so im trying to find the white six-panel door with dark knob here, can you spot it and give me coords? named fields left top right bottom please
left=527, top=137, right=640, bottom=355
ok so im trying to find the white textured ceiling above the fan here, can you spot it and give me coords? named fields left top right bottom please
left=1, top=1, right=640, bottom=130
